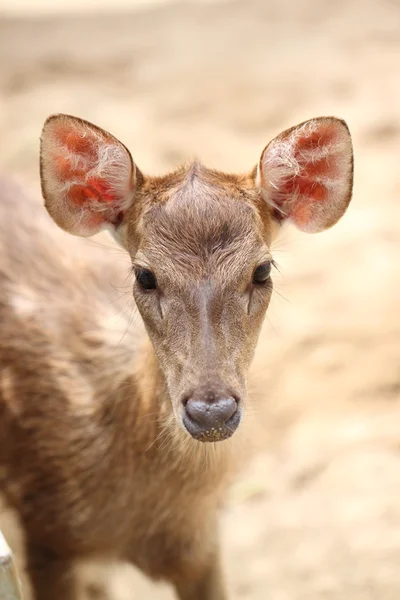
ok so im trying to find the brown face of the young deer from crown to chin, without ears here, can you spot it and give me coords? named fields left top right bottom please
left=125, top=165, right=272, bottom=440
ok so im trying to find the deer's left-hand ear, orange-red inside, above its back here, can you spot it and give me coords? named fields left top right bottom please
left=40, top=115, right=141, bottom=236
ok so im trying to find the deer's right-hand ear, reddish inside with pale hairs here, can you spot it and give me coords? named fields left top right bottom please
left=257, top=117, right=353, bottom=233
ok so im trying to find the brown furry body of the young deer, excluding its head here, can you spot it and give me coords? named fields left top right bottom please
left=0, top=170, right=268, bottom=600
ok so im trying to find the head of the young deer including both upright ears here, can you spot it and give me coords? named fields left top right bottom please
left=41, top=115, right=353, bottom=441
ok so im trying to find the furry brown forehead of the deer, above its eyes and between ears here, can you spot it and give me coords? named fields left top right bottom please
left=133, top=164, right=269, bottom=266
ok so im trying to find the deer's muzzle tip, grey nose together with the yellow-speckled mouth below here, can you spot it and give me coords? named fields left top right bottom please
left=183, top=392, right=241, bottom=441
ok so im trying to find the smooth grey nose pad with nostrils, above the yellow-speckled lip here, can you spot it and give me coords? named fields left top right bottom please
left=185, top=396, right=238, bottom=428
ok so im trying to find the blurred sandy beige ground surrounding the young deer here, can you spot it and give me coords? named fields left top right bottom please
left=0, top=0, right=400, bottom=600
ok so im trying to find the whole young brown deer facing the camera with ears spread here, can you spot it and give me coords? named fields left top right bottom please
left=0, top=115, right=353, bottom=600
